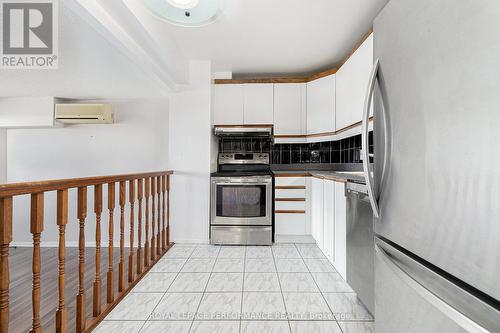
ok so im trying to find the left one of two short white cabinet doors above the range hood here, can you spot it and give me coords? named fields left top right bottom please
left=212, top=84, right=243, bottom=125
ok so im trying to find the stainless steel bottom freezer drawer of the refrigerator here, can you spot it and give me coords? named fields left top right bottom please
left=375, top=239, right=500, bottom=333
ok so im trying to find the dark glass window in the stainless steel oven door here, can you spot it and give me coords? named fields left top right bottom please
left=216, top=185, right=266, bottom=218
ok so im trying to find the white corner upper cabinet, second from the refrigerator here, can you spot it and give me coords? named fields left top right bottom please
left=307, top=74, right=335, bottom=134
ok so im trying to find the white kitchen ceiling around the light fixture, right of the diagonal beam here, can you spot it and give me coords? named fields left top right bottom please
left=124, top=0, right=388, bottom=75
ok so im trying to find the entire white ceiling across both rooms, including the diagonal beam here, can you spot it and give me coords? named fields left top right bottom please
left=0, top=0, right=388, bottom=99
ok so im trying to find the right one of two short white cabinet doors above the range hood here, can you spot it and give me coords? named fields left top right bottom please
left=243, top=83, right=273, bottom=125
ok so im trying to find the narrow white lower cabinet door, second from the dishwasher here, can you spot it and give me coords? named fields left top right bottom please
left=323, top=180, right=335, bottom=261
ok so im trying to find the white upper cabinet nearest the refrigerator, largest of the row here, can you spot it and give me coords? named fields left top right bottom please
left=336, top=34, right=373, bottom=130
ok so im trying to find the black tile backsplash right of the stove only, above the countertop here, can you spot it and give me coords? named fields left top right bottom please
left=272, top=132, right=373, bottom=164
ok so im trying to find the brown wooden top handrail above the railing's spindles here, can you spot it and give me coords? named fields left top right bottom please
left=0, top=171, right=174, bottom=198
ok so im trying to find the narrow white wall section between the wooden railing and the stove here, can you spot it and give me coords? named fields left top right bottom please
left=169, top=61, right=212, bottom=243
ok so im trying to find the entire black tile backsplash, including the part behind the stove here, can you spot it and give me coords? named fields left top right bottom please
left=219, top=132, right=373, bottom=164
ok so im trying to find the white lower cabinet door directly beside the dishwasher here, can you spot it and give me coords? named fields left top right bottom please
left=333, top=183, right=347, bottom=279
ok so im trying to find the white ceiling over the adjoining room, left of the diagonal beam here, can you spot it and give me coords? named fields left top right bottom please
left=0, top=0, right=170, bottom=99
